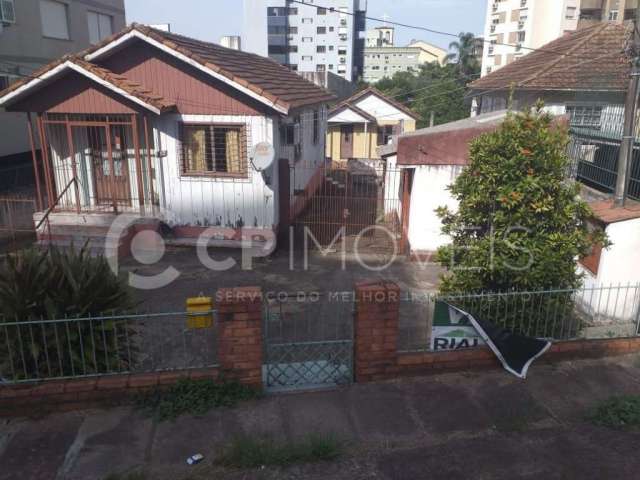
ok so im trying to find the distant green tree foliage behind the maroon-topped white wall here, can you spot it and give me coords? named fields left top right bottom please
left=376, top=63, right=470, bottom=128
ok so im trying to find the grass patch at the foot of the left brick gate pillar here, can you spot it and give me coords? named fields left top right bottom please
left=137, top=379, right=260, bottom=421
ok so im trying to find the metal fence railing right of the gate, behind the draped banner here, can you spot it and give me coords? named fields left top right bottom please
left=399, top=285, right=640, bottom=351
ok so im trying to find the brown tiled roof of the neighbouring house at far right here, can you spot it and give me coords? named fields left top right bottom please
left=470, top=22, right=633, bottom=93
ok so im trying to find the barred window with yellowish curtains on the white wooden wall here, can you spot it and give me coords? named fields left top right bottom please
left=180, top=123, right=247, bottom=177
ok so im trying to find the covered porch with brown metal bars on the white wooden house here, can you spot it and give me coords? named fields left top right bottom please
left=28, top=113, right=159, bottom=215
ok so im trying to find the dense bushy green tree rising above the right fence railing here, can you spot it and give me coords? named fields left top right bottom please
left=437, top=103, right=606, bottom=293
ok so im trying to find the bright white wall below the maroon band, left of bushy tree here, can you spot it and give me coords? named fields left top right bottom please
left=409, top=165, right=463, bottom=252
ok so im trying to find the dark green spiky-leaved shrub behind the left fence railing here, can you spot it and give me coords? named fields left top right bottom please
left=0, top=248, right=136, bottom=380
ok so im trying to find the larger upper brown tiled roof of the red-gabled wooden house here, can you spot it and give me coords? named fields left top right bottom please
left=0, top=23, right=334, bottom=114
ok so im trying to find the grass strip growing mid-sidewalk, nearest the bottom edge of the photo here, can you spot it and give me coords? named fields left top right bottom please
left=216, top=434, right=345, bottom=468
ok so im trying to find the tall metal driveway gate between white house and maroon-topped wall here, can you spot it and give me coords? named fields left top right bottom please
left=290, top=159, right=404, bottom=251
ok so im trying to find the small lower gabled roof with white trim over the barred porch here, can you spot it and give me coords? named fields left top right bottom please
left=0, top=55, right=175, bottom=114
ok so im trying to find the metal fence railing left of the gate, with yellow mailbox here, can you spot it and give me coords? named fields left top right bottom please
left=0, top=311, right=217, bottom=384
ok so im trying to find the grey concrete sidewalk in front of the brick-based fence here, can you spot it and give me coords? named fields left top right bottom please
left=0, top=355, right=640, bottom=480
